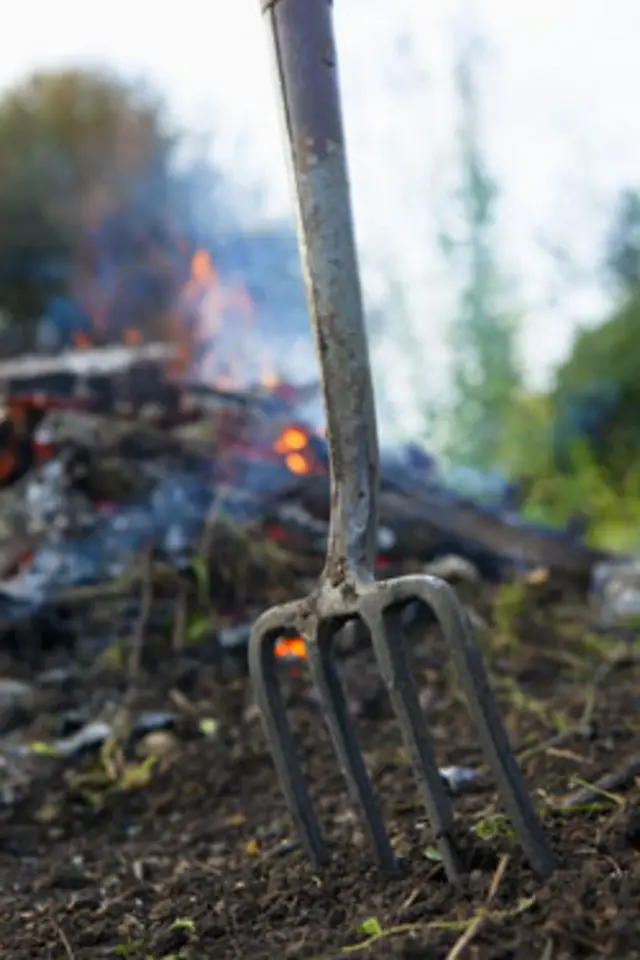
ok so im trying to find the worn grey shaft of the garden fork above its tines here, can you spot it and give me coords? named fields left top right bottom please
left=260, top=0, right=378, bottom=586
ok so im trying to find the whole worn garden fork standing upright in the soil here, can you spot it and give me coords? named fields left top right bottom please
left=249, top=0, right=554, bottom=880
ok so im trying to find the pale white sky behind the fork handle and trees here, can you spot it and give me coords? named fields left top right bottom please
left=0, top=0, right=640, bottom=436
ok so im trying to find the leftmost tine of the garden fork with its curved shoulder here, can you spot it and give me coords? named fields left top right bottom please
left=249, top=603, right=329, bottom=866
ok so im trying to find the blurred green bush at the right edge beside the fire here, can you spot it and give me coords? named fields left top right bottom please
left=490, top=280, right=640, bottom=551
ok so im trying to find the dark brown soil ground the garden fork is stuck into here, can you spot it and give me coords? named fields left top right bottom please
left=0, top=586, right=640, bottom=960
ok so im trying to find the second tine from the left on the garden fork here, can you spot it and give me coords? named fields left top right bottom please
left=307, top=622, right=398, bottom=874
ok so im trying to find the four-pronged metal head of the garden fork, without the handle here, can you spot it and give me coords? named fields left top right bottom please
left=249, top=576, right=554, bottom=880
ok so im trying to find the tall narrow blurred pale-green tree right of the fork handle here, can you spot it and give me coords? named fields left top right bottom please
left=440, top=26, right=521, bottom=469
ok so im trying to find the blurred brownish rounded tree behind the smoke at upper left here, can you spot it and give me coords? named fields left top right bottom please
left=0, top=70, right=189, bottom=338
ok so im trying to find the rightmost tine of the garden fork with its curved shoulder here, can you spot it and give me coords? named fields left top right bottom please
left=377, top=576, right=555, bottom=877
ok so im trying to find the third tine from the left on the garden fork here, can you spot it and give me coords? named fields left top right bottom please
left=361, top=596, right=462, bottom=882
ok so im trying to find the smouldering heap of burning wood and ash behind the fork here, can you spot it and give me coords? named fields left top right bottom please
left=0, top=334, right=620, bottom=672
